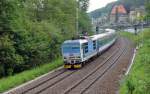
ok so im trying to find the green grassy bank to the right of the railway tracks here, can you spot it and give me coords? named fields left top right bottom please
left=120, top=29, right=150, bottom=94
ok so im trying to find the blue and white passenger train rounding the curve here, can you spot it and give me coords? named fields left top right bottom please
left=61, top=29, right=117, bottom=69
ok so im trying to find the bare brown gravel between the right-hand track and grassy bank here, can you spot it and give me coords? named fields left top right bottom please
left=83, top=37, right=134, bottom=94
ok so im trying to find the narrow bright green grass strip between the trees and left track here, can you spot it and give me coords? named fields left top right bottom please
left=0, top=59, right=63, bottom=93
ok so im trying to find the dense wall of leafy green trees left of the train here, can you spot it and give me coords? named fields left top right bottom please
left=0, top=0, right=91, bottom=78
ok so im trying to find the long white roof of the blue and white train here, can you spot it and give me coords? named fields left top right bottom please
left=63, top=29, right=115, bottom=44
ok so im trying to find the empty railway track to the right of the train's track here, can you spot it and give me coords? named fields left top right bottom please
left=62, top=38, right=127, bottom=94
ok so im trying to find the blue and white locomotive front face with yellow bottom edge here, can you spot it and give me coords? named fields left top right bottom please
left=62, top=40, right=82, bottom=69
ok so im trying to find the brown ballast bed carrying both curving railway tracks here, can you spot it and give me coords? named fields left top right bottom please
left=4, top=38, right=132, bottom=94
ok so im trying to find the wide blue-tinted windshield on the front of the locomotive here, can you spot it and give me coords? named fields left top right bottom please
left=62, top=43, right=80, bottom=53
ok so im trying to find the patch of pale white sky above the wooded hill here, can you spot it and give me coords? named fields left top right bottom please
left=88, top=0, right=117, bottom=12
